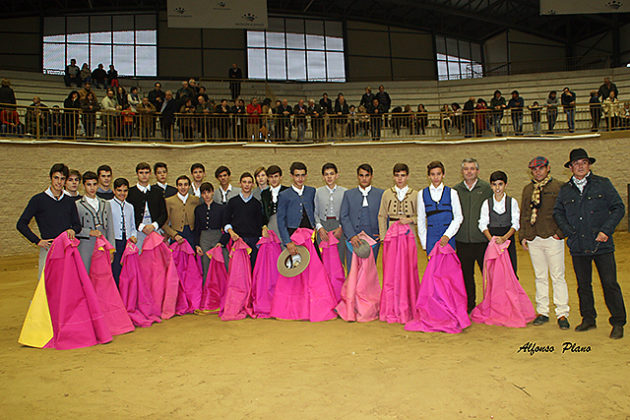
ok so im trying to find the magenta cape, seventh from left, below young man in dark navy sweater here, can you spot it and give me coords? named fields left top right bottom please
left=219, top=238, right=254, bottom=321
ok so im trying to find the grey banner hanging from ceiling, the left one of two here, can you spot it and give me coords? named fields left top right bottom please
left=167, top=0, right=267, bottom=29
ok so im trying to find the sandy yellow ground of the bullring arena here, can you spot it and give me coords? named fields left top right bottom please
left=0, top=233, right=630, bottom=420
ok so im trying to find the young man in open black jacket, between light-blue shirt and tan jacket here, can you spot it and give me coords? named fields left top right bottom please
left=127, top=162, right=167, bottom=252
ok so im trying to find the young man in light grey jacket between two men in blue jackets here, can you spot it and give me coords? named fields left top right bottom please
left=315, top=162, right=347, bottom=264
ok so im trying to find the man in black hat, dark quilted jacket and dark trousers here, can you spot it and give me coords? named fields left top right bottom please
left=553, top=149, right=626, bottom=338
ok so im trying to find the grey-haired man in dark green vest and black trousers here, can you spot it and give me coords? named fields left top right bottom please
left=453, top=158, right=492, bottom=313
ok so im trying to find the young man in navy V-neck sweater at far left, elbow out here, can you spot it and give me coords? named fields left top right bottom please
left=16, top=163, right=81, bottom=277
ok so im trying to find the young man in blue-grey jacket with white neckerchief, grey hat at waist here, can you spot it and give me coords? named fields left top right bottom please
left=340, top=163, right=383, bottom=264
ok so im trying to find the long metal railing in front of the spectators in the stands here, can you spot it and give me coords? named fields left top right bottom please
left=0, top=102, right=630, bottom=143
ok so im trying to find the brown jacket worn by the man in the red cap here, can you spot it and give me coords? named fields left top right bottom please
left=519, top=178, right=563, bottom=241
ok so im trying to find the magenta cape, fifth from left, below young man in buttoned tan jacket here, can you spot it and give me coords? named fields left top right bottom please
left=170, top=240, right=203, bottom=315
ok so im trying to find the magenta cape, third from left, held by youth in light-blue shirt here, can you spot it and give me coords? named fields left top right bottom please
left=118, top=241, right=161, bottom=327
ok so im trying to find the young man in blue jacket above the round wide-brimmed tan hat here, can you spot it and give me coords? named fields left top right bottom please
left=277, top=162, right=315, bottom=255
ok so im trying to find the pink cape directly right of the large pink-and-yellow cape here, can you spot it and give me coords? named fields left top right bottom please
left=90, top=235, right=134, bottom=335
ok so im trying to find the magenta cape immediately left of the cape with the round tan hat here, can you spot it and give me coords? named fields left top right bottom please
left=252, top=230, right=282, bottom=318
